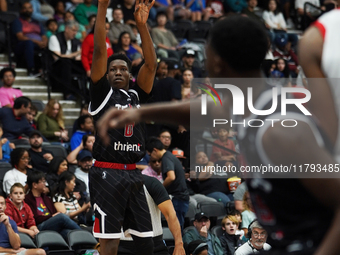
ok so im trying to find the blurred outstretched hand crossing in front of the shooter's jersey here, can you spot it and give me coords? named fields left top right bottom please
left=97, top=108, right=141, bottom=145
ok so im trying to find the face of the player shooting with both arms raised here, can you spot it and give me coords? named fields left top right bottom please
left=107, top=59, right=130, bottom=90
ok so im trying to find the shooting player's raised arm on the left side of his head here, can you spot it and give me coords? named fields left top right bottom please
left=91, top=0, right=109, bottom=84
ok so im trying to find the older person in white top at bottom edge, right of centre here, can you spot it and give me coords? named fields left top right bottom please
left=235, top=220, right=271, bottom=255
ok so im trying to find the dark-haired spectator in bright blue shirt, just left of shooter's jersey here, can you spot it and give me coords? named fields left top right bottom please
left=70, top=114, right=94, bottom=151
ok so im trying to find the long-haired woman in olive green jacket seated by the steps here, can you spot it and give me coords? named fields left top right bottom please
left=37, top=99, right=69, bottom=142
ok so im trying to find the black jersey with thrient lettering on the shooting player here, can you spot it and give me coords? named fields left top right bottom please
left=89, top=75, right=149, bottom=164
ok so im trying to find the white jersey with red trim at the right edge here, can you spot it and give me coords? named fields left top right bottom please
left=314, top=9, right=340, bottom=162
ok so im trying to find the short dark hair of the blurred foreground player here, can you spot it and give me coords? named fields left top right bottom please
left=208, top=15, right=268, bottom=72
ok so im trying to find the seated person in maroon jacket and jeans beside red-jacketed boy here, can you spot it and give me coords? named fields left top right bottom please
left=25, top=171, right=80, bottom=240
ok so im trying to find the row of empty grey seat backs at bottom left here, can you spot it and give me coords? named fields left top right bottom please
left=19, top=229, right=98, bottom=255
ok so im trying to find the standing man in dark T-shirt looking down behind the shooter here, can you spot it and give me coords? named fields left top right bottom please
left=146, top=137, right=189, bottom=229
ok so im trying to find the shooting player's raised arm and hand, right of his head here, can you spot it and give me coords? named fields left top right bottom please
left=134, top=0, right=157, bottom=94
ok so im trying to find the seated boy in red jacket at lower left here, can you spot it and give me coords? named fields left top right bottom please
left=5, top=183, right=39, bottom=238
